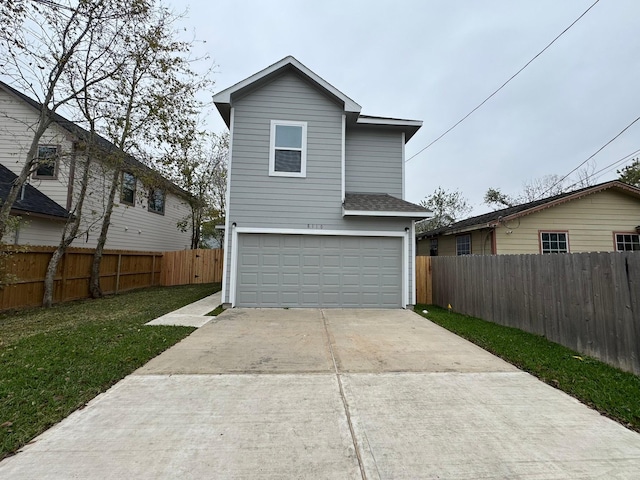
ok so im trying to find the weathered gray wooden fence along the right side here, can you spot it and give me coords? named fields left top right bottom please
left=432, top=252, right=640, bottom=374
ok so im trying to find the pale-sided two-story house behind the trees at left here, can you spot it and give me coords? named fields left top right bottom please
left=0, top=82, right=191, bottom=251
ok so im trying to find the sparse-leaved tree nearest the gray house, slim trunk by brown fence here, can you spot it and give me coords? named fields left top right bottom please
left=89, top=7, right=210, bottom=298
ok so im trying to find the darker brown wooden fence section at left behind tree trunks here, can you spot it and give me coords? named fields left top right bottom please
left=0, top=246, right=163, bottom=310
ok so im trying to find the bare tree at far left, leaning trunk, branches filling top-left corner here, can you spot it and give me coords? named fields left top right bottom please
left=0, top=0, right=142, bottom=241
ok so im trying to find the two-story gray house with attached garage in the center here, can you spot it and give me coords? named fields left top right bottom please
left=214, top=57, right=429, bottom=308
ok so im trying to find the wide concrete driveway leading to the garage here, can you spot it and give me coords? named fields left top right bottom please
left=0, top=309, right=640, bottom=479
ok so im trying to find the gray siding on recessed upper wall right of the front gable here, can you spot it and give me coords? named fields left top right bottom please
left=345, top=127, right=403, bottom=198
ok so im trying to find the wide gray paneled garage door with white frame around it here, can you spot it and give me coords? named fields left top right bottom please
left=236, top=233, right=402, bottom=308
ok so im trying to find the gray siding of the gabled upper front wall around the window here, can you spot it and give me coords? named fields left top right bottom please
left=229, top=73, right=342, bottom=228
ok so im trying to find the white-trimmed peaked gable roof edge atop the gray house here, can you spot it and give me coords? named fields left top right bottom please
left=213, top=55, right=362, bottom=127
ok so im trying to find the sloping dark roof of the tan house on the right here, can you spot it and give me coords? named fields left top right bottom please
left=417, top=180, right=640, bottom=238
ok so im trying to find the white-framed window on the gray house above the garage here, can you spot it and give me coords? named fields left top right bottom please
left=269, top=120, right=307, bottom=177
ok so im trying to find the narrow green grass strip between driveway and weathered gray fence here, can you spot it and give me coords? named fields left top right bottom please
left=415, top=305, right=640, bottom=432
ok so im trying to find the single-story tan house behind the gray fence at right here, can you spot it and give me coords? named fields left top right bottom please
left=416, top=181, right=640, bottom=256
